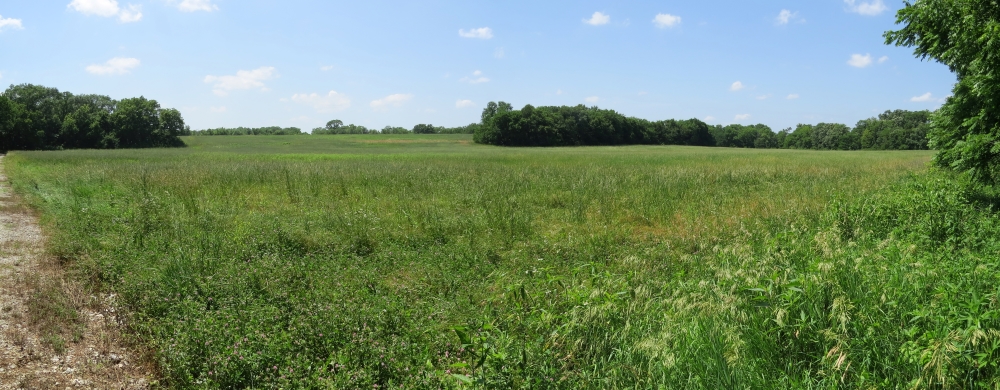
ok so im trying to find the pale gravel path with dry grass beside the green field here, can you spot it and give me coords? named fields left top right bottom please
left=0, top=156, right=150, bottom=390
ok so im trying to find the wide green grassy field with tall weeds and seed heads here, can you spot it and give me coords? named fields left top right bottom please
left=7, top=135, right=1000, bottom=389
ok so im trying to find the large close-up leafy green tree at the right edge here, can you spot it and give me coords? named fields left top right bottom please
left=884, top=0, right=1000, bottom=184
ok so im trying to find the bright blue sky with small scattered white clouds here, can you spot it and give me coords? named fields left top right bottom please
left=0, top=0, right=955, bottom=131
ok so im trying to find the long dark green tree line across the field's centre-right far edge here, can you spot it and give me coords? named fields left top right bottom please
left=474, top=102, right=931, bottom=150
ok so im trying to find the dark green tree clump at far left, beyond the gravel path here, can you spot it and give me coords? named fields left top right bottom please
left=0, top=84, right=188, bottom=152
